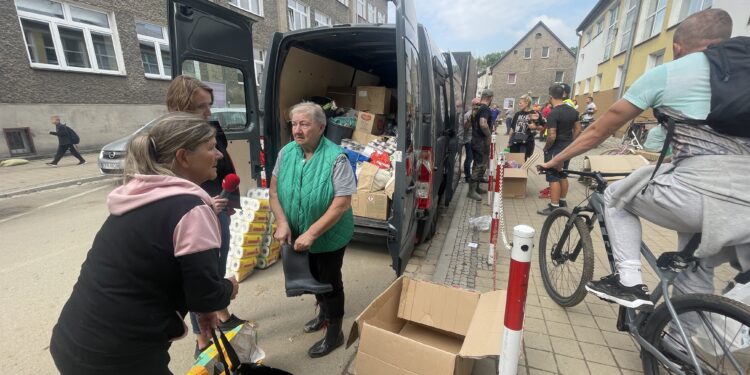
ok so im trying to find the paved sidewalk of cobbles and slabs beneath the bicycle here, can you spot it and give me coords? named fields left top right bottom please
left=406, top=136, right=733, bottom=375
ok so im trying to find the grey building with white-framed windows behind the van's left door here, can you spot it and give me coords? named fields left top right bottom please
left=0, top=0, right=388, bottom=158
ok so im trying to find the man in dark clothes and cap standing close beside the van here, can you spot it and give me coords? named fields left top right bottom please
left=466, top=89, right=494, bottom=201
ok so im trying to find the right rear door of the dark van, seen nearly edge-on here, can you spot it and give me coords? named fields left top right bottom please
left=388, top=0, right=422, bottom=275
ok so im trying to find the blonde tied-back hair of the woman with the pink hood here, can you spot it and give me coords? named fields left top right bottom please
left=123, top=112, right=216, bottom=183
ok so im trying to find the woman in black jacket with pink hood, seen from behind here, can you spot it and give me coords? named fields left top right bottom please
left=50, top=113, right=238, bottom=375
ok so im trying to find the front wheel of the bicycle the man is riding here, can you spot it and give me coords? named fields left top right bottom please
left=539, top=209, right=594, bottom=307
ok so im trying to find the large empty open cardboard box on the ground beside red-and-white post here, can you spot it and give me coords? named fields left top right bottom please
left=346, top=276, right=506, bottom=375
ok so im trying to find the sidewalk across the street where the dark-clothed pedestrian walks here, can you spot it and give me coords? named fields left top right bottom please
left=0, top=153, right=114, bottom=198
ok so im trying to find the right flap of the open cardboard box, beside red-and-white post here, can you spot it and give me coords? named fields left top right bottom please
left=458, top=290, right=507, bottom=358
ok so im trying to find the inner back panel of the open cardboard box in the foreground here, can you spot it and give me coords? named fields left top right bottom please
left=398, top=278, right=480, bottom=336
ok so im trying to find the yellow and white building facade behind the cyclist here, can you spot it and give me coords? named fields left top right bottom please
left=573, top=0, right=750, bottom=121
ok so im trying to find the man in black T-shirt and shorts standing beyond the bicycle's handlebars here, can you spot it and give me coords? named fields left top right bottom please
left=537, top=84, right=581, bottom=215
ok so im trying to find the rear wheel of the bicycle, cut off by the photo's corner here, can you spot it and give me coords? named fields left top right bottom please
left=641, top=294, right=750, bottom=374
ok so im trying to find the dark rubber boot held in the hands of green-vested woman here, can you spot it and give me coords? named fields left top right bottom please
left=281, top=244, right=333, bottom=297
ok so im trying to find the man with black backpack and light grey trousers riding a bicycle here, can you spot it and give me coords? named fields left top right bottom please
left=539, top=9, right=750, bottom=308
